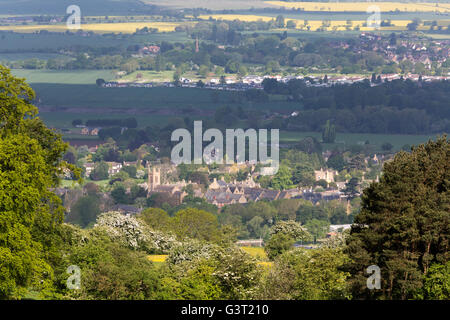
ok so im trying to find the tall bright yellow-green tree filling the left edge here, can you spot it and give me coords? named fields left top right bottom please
left=0, top=66, right=79, bottom=299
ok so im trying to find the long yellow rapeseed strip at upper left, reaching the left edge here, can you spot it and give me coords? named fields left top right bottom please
left=0, top=22, right=191, bottom=33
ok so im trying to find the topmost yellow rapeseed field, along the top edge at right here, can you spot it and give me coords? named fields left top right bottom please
left=267, top=1, right=450, bottom=12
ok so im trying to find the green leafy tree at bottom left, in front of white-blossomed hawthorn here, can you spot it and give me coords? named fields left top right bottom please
left=64, top=229, right=162, bottom=300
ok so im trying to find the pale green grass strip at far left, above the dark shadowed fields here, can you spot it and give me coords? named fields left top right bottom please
left=11, top=69, right=114, bottom=84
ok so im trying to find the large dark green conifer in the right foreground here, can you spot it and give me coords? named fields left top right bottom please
left=347, top=136, right=450, bottom=299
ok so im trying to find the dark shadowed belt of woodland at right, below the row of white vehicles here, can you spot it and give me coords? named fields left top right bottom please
left=264, top=79, right=450, bottom=134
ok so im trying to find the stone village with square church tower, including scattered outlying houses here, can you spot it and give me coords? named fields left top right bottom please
left=58, top=147, right=391, bottom=214
